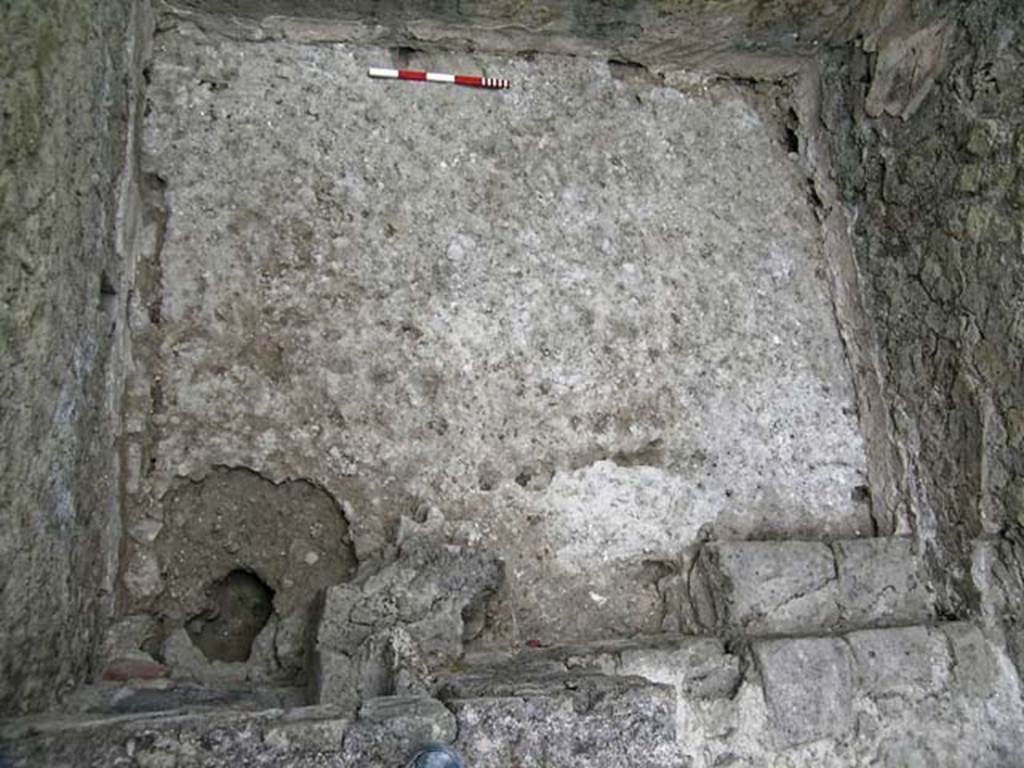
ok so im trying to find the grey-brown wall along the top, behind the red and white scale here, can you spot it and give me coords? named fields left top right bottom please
left=168, top=0, right=894, bottom=77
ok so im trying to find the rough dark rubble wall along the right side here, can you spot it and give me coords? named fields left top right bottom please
left=822, top=0, right=1024, bottom=613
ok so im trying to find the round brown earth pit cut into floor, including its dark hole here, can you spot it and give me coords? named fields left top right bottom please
left=151, top=467, right=356, bottom=678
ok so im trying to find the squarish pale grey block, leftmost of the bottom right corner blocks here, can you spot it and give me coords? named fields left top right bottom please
left=753, top=638, right=854, bottom=748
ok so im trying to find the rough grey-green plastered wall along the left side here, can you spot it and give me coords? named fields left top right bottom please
left=0, top=0, right=146, bottom=713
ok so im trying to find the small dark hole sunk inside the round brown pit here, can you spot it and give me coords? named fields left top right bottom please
left=185, top=570, right=273, bottom=662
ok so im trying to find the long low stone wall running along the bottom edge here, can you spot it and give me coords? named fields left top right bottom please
left=0, top=623, right=1024, bottom=768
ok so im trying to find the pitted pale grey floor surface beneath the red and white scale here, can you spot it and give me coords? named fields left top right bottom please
left=134, top=26, right=871, bottom=640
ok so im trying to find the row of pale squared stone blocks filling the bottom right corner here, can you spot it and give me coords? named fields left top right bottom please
left=754, top=624, right=1024, bottom=768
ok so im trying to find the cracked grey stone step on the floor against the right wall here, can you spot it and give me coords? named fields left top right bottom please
left=684, top=538, right=935, bottom=635
